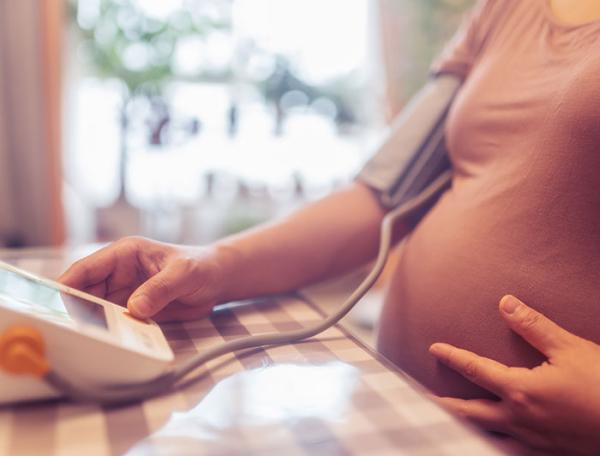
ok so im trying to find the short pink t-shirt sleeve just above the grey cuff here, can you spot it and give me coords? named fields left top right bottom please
left=431, top=0, right=502, bottom=79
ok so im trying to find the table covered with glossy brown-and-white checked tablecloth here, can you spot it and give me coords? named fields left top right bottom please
left=0, top=250, right=502, bottom=456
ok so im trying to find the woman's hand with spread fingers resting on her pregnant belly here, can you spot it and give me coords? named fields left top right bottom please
left=430, top=296, right=600, bottom=454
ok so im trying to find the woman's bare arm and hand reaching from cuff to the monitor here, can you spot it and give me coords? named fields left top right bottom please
left=60, top=183, right=406, bottom=320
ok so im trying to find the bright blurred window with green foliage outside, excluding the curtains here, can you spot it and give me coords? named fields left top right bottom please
left=65, top=0, right=472, bottom=243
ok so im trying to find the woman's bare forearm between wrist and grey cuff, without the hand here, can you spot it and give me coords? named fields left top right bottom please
left=216, top=183, right=404, bottom=301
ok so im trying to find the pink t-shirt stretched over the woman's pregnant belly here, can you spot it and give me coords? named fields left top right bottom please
left=379, top=0, right=600, bottom=397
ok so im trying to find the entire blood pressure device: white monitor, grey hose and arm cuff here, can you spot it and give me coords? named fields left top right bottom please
left=0, top=76, right=454, bottom=404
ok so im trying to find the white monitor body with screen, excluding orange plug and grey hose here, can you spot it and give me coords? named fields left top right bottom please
left=0, top=262, right=173, bottom=403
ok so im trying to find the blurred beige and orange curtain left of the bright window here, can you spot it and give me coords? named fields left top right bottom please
left=0, top=0, right=65, bottom=246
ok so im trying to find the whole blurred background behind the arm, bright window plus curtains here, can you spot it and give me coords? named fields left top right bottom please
left=0, top=0, right=473, bottom=247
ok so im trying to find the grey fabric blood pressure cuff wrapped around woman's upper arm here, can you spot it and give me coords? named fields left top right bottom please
left=356, top=75, right=461, bottom=224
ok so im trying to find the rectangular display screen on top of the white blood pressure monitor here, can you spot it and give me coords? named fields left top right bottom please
left=0, top=269, right=108, bottom=329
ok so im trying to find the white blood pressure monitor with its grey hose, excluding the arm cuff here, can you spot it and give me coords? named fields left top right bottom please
left=0, top=171, right=452, bottom=404
